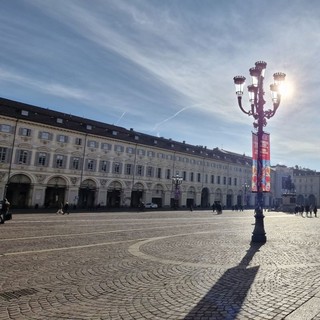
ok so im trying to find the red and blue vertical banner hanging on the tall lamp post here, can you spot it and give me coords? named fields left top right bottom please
left=251, top=132, right=271, bottom=192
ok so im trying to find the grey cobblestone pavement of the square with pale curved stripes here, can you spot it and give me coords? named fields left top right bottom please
left=0, top=210, right=320, bottom=320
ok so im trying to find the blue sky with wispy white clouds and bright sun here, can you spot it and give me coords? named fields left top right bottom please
left=0, top=0, right=320, bottom=171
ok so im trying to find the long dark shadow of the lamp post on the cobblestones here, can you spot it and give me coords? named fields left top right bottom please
left=184, top=243, right=264, bottom=320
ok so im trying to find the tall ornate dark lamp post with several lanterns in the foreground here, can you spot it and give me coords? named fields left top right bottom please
left=233, top=61, right=286, bottom=242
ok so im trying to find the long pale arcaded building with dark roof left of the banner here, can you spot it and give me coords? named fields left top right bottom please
left=0, top=98, right=310, bottom=209
